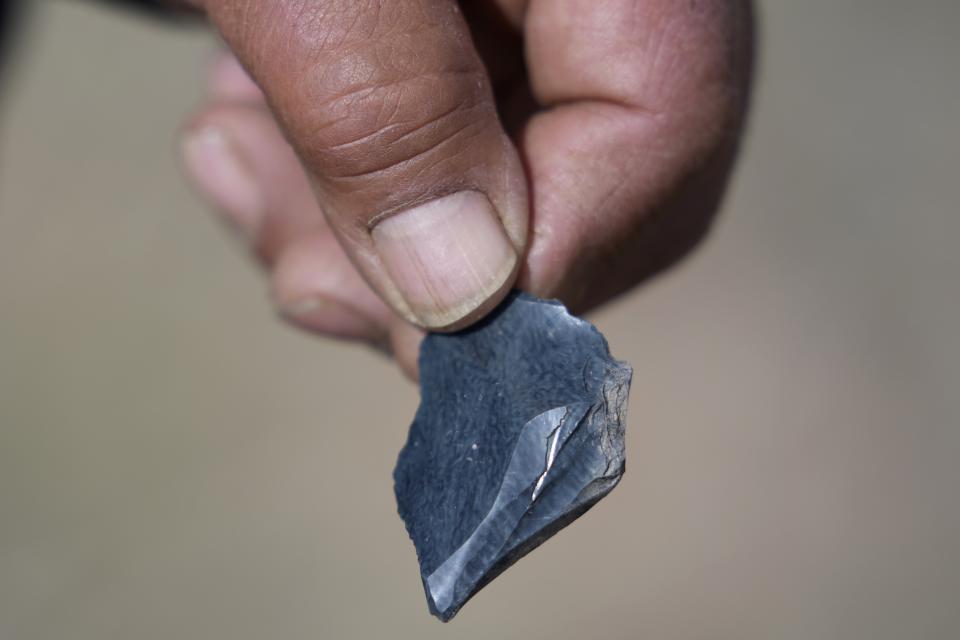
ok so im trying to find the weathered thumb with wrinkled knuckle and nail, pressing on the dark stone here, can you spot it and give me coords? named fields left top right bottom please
left=195, top=0, right=528, bottom=329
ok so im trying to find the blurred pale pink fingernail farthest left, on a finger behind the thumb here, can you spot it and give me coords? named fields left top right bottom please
left=183, top=127, right=264, bottom=240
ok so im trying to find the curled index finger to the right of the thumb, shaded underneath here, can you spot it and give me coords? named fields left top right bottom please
left=520, top=0, right=752, bottom=310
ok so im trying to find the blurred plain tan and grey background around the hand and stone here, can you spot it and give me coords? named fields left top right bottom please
left=0, top=0, right=960, bottom=640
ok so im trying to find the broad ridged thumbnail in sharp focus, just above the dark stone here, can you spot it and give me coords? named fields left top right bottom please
left=372, top=191, right=517, bottom=329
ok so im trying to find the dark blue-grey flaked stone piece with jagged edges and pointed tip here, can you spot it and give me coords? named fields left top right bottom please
left=394, top=292, right=632, bottom=622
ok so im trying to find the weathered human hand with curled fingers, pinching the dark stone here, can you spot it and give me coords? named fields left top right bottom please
left=178, top=0, right=753, bottom=377
